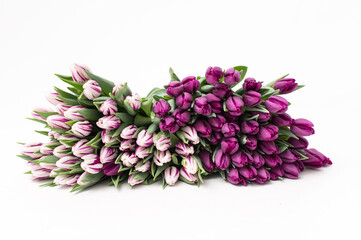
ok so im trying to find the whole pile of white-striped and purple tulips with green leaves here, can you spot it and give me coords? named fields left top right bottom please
left=19, top=64, right=332, bottom=191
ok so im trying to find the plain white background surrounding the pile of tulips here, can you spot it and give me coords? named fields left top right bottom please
left=0, top=0, right=361, bottom=240
